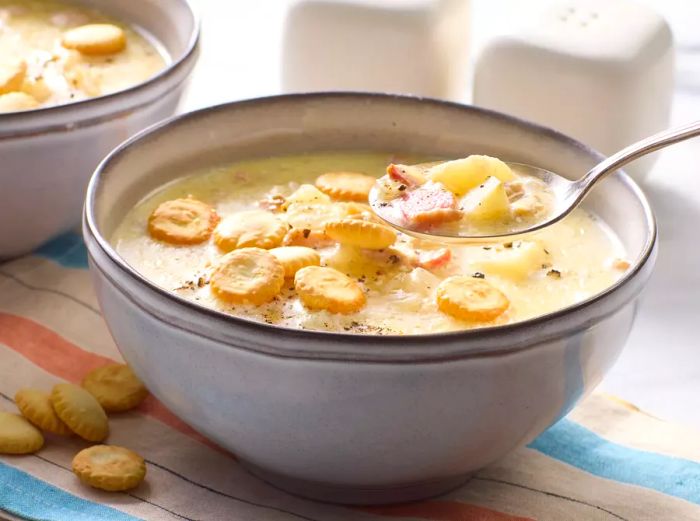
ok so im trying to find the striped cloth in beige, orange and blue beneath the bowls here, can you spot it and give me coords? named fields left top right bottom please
left=0, top=234, right=700, bottom=521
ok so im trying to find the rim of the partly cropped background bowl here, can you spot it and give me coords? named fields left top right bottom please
left=0, top=0, right=202, bottom=134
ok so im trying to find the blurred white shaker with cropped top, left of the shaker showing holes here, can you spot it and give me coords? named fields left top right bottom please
left=282, top=0, right=470, bottom=99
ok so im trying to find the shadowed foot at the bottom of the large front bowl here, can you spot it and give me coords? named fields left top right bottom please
left=239, top=460, right=472, bottom=505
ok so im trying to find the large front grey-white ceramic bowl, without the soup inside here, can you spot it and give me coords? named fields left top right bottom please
left=84, top=93, right=656, bottom=503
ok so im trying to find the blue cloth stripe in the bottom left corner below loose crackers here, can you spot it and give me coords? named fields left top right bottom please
left=0, top=461, right=140, bottom=521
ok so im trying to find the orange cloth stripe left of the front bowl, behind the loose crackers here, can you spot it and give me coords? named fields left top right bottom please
left=0, top=313, right=226, bottom=452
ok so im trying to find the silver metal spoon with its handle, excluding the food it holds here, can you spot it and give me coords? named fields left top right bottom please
left=369, top=121, right=700, bottom=243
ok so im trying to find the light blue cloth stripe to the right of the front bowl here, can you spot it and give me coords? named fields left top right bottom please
left=529, top=419, right=700, bottom=505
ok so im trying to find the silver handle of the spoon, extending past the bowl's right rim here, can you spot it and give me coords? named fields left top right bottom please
left=577, top=121, right=700, bottom=195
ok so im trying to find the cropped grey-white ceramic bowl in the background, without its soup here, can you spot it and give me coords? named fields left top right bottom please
left=0, top=0, right=199, bottom=259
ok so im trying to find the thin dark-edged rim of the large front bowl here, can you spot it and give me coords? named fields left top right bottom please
left=83, top=91, right=658, bottom=354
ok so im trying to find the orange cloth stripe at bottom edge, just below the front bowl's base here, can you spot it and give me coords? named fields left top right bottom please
left=362, top=501, right=535, bottom=521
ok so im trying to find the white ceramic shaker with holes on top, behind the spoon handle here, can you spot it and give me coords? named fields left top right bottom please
left=473, top=0, right=674, bottom=177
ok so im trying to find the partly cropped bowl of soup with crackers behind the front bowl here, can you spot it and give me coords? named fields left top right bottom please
left=0, top=0, right=199, bottom=259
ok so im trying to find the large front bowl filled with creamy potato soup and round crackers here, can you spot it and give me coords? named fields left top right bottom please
left=84, top=93, right=656, bottom=504
